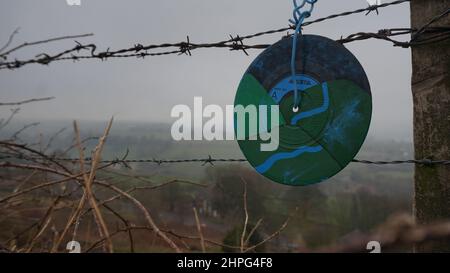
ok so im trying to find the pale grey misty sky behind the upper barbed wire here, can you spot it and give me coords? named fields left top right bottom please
left=0, top=0, right=412, bottom=139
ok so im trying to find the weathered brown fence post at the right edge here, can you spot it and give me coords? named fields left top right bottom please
left=411, top=0, right=450, bottom=252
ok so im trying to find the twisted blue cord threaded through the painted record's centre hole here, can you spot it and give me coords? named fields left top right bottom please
left=289, top=0, right=318, bottom=112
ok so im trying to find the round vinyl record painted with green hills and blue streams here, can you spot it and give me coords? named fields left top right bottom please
left=234, top=35, right=372, bottom=186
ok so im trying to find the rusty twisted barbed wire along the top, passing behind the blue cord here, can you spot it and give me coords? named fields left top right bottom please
left=0, top=0, right=450, bottom=70
